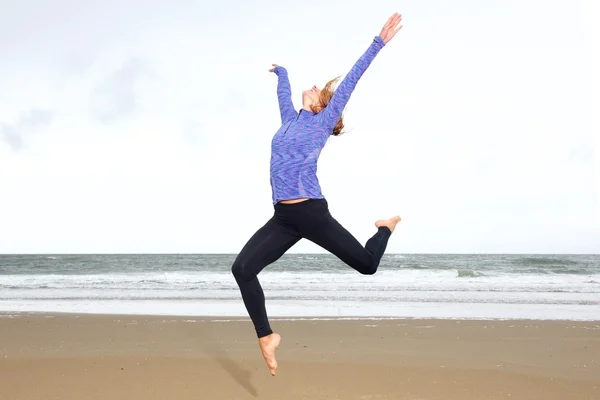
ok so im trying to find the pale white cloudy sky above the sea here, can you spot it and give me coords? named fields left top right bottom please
left=0, top=0, right=600, bottom=253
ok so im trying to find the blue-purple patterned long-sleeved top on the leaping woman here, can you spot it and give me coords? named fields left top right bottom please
left=271, top=36, right=385, bottom=204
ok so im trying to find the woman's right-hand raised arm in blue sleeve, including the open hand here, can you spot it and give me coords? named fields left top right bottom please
left=321, top=13, right=402, bottom=127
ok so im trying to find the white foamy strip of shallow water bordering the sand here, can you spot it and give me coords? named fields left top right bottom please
left=0, top=298, right=600, bottom=321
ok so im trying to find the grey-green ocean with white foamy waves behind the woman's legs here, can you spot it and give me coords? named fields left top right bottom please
left=0, top=254, right=600, bottom=320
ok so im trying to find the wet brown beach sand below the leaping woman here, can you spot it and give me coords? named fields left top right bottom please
left=0, top=314, right=600, bottom=400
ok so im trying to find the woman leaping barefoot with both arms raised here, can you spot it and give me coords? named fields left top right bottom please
left=232, top=13, right=402, bottom=376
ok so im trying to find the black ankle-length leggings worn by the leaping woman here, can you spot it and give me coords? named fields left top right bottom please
left=231, top=199, right=391, bottom=338
